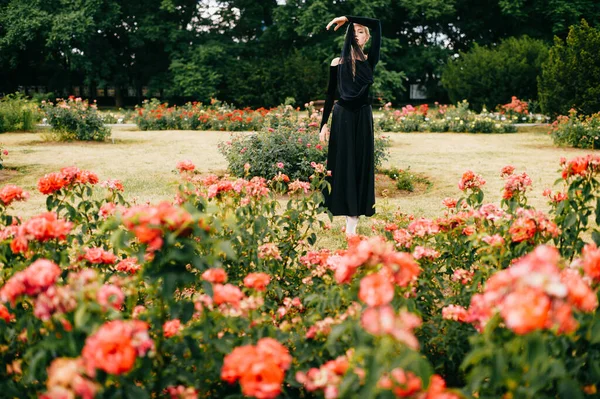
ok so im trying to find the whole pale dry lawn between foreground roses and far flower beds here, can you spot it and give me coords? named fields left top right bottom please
left=0, top=127, right=589, bottom=226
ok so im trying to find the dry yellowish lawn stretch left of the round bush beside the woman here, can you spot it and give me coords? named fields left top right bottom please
left=1, top=128, right=229, bottom=216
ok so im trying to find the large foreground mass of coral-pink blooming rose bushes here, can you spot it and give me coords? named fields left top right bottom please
left=0, top=155, right=600, bottom=398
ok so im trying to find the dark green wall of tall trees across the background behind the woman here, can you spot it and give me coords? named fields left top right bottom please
left=0, top=0, right=600, bottom=107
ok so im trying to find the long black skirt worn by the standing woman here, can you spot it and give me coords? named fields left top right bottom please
left=323, top=104, right=375, bottom=216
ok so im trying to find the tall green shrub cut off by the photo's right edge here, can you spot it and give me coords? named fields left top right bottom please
left=538, top=20, right=600, bottom=116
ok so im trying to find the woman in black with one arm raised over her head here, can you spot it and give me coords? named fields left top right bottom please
left=319, top=16, right=381, bottom=235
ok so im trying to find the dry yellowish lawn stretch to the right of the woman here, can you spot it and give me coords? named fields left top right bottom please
left=384, top=132, right=590, bottom=217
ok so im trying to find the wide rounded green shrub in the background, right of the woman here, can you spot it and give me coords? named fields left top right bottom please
left=442, top=36, right=548, bottom=111
